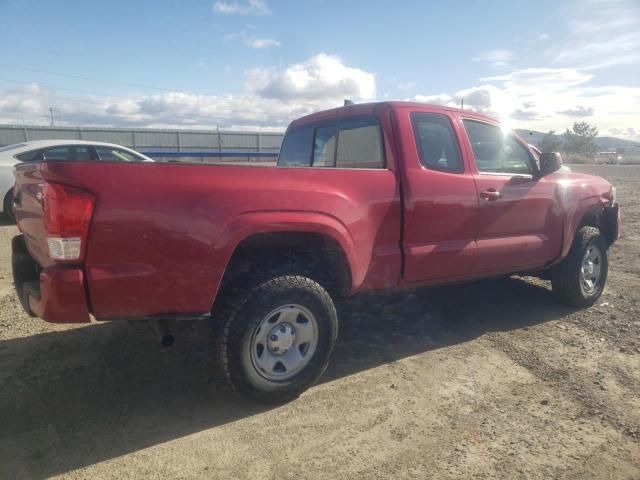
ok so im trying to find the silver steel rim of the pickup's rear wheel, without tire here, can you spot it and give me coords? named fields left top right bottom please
left=250, top=304, right=318, bottom=381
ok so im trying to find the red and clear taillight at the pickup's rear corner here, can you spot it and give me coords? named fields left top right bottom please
left=42, top=183, right=95, bottom=260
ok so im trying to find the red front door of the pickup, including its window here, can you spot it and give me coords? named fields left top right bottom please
left=462, top=119, right=562, bottom=275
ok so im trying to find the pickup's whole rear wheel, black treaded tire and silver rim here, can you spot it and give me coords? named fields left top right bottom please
left=215, top=275, right=338, bottom=403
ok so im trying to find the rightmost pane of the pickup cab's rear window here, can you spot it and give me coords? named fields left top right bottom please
left=336, top=118, right=384, bottom=168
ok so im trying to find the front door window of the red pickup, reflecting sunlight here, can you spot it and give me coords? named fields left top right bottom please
left=463, top=120, right=532, bottom=174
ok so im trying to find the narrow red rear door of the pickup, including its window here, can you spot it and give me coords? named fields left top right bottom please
left=395, top=108, right=478, bottom=282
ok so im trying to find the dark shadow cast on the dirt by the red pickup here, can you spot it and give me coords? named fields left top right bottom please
left=0, top=278, right=570, bottom=478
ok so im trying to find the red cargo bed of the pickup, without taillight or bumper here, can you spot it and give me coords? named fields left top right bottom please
left=16, top=162, right=401, bottom=319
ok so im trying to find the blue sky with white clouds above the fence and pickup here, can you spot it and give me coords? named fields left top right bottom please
left=0, top=0, right=640, bottom=141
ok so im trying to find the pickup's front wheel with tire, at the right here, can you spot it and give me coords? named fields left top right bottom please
left=551, top=227, right=609, bottom=308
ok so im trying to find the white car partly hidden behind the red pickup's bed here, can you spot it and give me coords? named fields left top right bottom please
left=0, top=140, right=153, bottom=220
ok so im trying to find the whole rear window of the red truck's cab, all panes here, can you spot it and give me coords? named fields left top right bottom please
left=278, top=117, right=384, bottom=168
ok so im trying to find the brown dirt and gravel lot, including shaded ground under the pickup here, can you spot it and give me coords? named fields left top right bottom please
left=0, top=166, right=640, bottom=479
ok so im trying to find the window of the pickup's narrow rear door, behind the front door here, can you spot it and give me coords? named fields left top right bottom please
left=411, top=112, right=464, bottom=172
